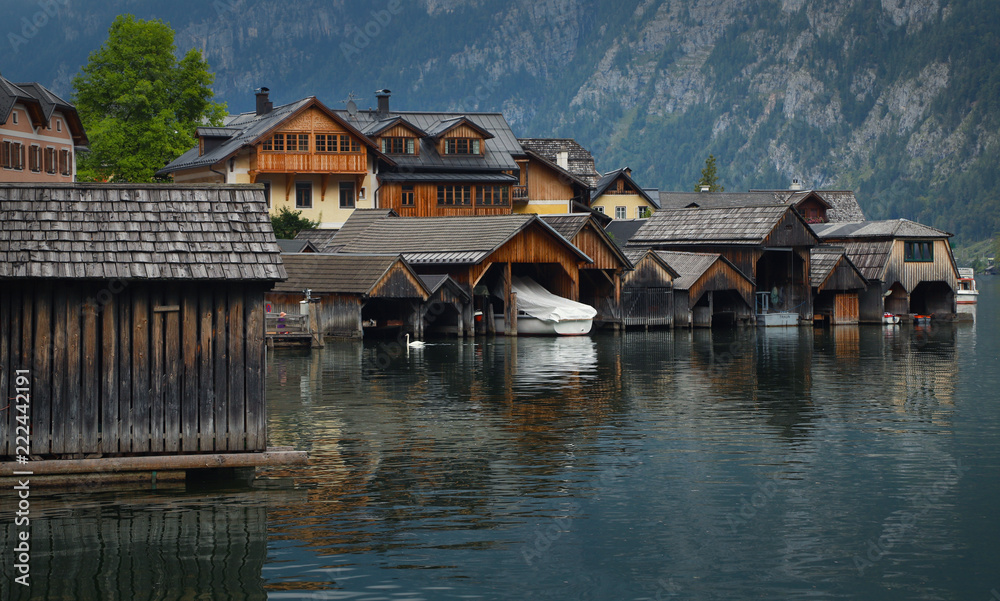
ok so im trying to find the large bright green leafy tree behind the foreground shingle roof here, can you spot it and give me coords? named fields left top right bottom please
left=73, top=15, right=226, bottom=182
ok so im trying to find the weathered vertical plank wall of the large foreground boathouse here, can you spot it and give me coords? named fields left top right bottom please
left=0, top=282, right=267, bottom=457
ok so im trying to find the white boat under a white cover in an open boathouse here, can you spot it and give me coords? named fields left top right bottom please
left=494, top=277, right=597, bottom=336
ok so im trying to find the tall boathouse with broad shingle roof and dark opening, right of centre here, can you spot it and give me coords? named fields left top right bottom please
left=627, top=204, right=819, bottom=322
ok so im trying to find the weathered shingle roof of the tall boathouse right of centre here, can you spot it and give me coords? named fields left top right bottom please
left=629, top=205, right=818, bottom=246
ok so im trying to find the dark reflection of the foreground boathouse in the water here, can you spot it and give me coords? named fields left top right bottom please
left=0, top=491, right=267, bottom=601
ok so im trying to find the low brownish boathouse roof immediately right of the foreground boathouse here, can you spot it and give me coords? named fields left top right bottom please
left=274, top=253, right=430, bottom=299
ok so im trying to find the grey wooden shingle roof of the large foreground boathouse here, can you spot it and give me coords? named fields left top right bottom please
left=0, top=184, right=285, bottom=281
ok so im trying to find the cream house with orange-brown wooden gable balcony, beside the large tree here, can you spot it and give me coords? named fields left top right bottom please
left=157, top=88, right=394, bottom=228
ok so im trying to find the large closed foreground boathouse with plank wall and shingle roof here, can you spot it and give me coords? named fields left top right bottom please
left=0, top=184, right=305, bottom=475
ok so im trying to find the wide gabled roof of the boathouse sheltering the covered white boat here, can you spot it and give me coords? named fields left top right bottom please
left=340, top=214, right=591, bottom=265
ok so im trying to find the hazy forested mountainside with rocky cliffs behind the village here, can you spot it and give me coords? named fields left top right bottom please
left=7, top=0, right=1000, bottom=242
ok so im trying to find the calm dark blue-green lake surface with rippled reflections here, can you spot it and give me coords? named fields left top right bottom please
left=0, top=277, right=1000, bottom=601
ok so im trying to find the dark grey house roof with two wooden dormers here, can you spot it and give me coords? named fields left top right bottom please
left=335, top=110, right=522, bottom=171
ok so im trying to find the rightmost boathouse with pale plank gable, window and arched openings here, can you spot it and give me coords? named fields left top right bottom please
left=813, top=219, right=958, bottom=322
